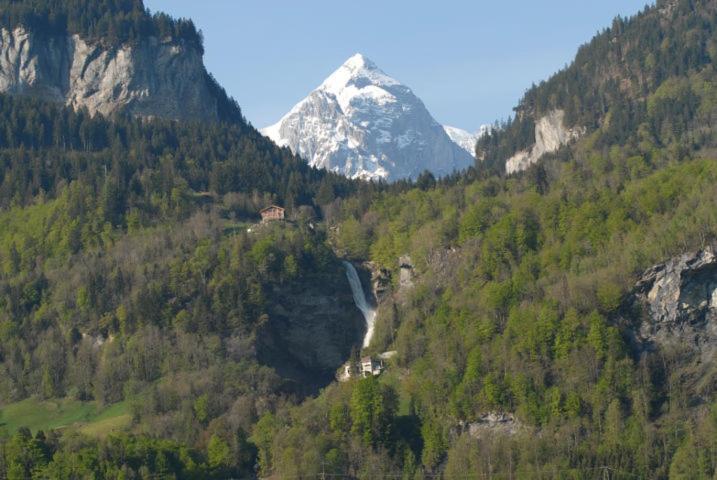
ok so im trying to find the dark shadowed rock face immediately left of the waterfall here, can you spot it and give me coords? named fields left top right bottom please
left=257, top=266, right=366, bottom=393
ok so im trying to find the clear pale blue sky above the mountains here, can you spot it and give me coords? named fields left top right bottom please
left=145, top=0, right=652, bottom=131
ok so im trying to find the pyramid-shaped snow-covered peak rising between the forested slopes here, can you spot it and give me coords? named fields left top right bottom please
left=262, top=54, right=473, bottom=180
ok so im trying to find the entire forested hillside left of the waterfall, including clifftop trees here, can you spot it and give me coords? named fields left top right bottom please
left=0, top=1, right=365, bottom=478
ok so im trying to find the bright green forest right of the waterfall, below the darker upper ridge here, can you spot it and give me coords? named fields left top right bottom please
left=272, top=151, right=717, bottom=478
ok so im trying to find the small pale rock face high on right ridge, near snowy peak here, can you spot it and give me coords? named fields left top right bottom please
left=505, top=110, right=585, bottom=174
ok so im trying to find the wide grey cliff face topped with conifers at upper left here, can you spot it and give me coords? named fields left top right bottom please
left=0, top=27, right=218, bottom=121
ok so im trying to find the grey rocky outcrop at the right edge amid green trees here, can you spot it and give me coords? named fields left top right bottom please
left=634, top=247, right=717, bottom=362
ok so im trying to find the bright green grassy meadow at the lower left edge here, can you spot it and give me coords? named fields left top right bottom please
left=0, top=398, right=132, bottom=437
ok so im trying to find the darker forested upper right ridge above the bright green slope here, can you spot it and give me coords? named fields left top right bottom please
left=477, top=0, right=717, bottom=173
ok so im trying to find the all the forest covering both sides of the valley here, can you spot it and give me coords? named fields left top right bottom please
left=0, top=0, right=717, bottom=479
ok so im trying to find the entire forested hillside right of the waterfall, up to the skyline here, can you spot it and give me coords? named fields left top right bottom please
left=253, top=1, right=717, bottom=479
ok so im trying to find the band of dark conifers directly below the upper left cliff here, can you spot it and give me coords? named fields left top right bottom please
left=0, top=93, right=354, bottom=217
